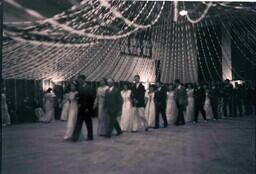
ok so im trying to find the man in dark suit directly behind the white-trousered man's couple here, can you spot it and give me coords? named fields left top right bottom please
left=155, top=82, right=168, bottom=129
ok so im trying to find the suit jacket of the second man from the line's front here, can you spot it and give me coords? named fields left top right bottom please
left=103, top=87, right=122, bottom=117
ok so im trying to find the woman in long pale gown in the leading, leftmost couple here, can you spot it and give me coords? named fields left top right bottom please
left=64, top=84, right=78, bottom=140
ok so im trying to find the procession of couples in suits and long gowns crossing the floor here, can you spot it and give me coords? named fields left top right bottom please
left=56, top=75, right=256, bottom=141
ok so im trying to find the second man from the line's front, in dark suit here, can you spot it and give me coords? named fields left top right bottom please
left=103, top=78, right=122, bottom=138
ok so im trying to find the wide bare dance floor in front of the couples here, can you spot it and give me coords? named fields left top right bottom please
left=2, top=117, right=256, bottom=174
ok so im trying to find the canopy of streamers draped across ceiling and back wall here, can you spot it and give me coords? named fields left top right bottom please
left=2, top=0, right=256, bottom=83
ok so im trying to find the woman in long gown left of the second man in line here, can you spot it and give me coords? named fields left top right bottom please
left=94, top=79, right=108, bottom=136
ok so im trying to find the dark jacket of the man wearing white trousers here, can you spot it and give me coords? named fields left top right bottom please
left=131, top=83, right=145, bottom=107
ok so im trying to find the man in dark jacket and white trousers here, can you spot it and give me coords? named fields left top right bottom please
left=131, top=75, right=148, bottom=132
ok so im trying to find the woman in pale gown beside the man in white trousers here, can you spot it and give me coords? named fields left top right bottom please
left=120, top=82, right=133, bottom=131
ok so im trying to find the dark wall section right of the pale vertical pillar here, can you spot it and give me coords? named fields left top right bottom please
left=231, top=18, right=256, bottom=80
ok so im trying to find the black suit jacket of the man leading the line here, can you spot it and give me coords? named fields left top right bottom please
left=78, top=85, right=95, bottom=111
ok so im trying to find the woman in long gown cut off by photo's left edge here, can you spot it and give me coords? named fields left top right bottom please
left=1, top=88, right=11, bottom=126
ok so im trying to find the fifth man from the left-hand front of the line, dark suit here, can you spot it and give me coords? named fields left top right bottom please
left=174, top=79, right=188, bottom=126
